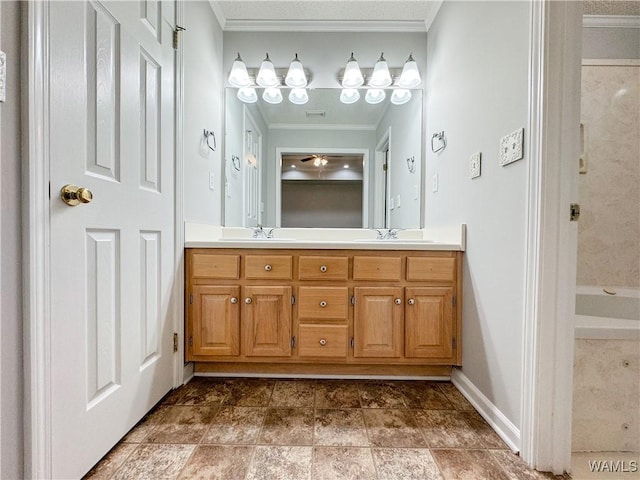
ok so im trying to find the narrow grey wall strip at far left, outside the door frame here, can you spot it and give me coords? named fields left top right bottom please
left=0, top=1, right=24, bottom=479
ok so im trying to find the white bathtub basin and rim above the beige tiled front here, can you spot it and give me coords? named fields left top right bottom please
left=575, top=286, right=640, bottom=340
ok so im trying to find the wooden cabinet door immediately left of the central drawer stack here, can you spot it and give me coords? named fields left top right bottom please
left=242, top=286, right=291, bottom=357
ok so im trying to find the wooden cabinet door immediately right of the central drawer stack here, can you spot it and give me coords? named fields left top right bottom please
left=353, top=287, right=404, bottom=357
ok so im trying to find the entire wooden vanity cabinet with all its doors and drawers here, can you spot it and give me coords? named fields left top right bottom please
left=186, top=248, right=462, bottom=375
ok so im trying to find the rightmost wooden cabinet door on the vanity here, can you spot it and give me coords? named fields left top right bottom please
left=405, top=287, right=453, bottom=359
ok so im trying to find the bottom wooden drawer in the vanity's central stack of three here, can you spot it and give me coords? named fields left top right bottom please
left=298, top=325, right=348, bottom=357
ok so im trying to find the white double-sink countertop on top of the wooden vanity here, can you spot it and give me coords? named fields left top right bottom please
left=185, top=222, right=466, bottom=251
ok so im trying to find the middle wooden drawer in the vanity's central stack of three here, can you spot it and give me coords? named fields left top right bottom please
left=298, top=287, right=349, bottom=320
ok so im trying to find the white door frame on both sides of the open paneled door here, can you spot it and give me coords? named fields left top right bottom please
left=22, top=2, right=184, bottom=478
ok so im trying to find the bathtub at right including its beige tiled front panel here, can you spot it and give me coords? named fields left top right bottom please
left=572, top=287, right=640, bottom=452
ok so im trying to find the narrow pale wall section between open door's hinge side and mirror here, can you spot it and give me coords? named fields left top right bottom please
left=181, top=2, right=224, bottom=225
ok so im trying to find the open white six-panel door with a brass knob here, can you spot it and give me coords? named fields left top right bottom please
left=48, top=1, right=175, bottom=478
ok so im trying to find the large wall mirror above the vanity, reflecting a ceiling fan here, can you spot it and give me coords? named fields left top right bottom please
left=224, top=88, right=424, bottom=228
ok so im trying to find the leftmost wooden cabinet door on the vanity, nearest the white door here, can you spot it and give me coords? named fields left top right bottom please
left=191, top=286, right=240, bottom=356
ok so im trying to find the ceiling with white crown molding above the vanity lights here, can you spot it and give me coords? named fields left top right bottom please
left=210, top=0, right=442, bottom=31
